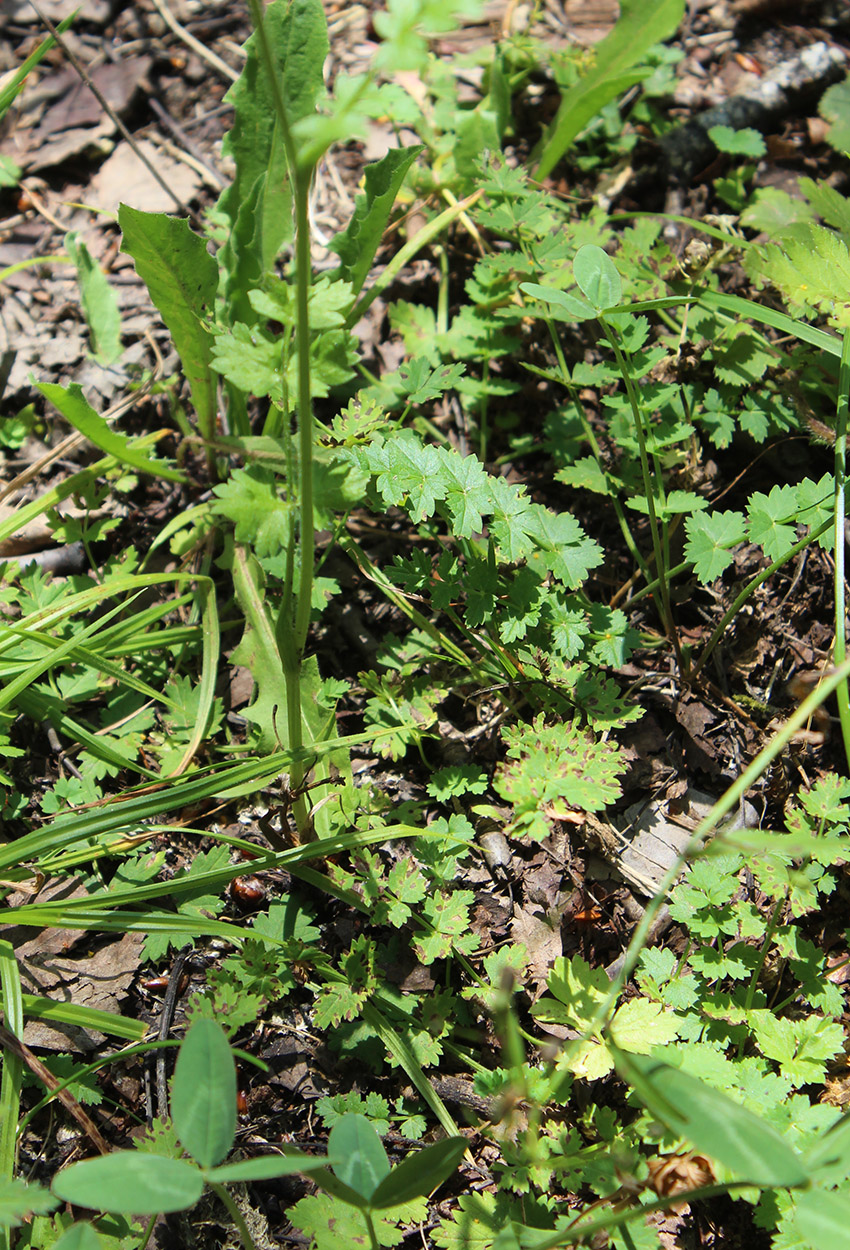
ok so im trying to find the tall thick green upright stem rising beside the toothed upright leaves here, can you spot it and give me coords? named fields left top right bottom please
left=249, top=0, right=315, bottom=840
